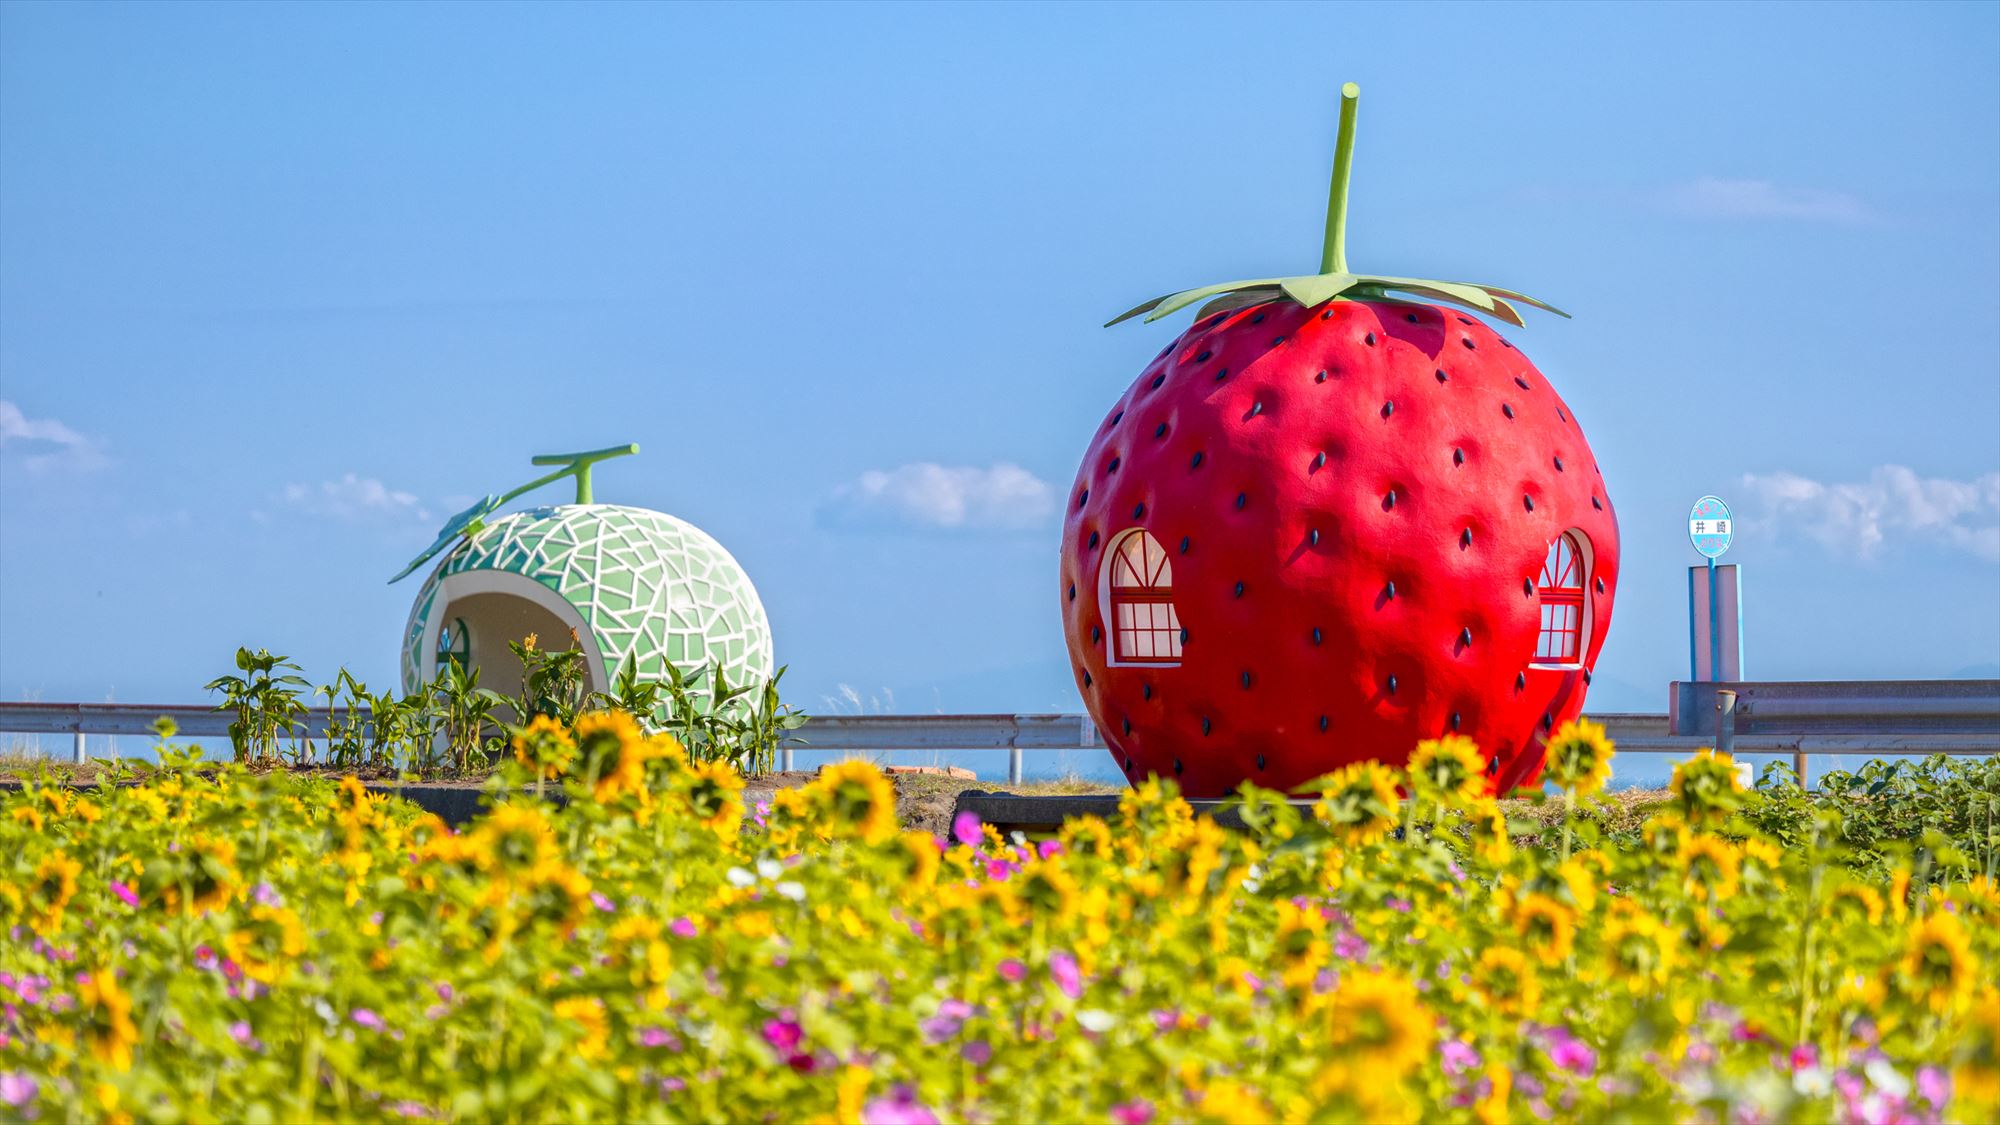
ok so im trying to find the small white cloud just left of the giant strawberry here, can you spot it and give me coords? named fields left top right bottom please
left=822, top=460, right=1056, bottom=530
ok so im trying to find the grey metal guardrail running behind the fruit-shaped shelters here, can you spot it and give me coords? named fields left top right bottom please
left=0, top=681, right=2000, bottom=783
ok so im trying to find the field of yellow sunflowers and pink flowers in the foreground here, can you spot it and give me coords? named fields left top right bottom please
left=0, top=713, right=2000, bottom=1125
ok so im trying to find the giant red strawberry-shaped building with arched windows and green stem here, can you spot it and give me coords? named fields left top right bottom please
left=1062, top=84, right=1618, bottom=797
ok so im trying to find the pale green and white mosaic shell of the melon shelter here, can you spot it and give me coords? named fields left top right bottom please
left=402, top=504, right=774, bottom=691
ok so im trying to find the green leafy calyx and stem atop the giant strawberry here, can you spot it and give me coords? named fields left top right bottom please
left=1104, top=82, right=1568, bottom=328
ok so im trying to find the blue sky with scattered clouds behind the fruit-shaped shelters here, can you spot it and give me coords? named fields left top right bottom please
left=0, top=2, right=2000, bottom=736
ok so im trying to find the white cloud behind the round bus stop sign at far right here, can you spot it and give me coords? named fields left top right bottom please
left=1744, top=464, right=2000, bottom=563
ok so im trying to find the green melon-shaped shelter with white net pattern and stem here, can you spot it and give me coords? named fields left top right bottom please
left=390, top=444, right=774, bottom=695
